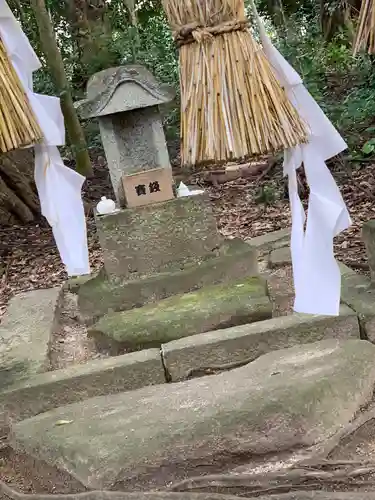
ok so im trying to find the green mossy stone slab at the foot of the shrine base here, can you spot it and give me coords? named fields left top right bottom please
left=89, top=277, right=272, bottom=353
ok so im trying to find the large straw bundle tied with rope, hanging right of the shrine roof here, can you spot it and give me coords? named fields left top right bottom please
left=162, top=0, right=307, bottom=167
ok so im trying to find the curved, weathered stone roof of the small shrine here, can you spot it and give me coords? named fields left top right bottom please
left=75, top=64, right=175, bottom=119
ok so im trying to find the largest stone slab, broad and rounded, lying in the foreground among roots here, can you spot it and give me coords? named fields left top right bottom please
left=10, top=340, right=375, bottom=491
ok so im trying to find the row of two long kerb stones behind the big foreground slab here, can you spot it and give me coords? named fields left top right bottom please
left=0, top=306, right=359, bottom=427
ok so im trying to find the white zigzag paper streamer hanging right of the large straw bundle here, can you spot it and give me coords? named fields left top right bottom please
left=254, top=6, right=351, bottom=316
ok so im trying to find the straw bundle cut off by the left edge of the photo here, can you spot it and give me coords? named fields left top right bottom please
left=0, top=38, right=43, bottom=153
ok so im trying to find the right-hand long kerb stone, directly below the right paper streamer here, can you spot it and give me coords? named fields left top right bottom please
left=162, top=306, right=360, bottom=381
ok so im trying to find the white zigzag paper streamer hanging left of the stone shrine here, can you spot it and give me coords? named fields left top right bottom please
left=0, top=0, right=90, bottom=276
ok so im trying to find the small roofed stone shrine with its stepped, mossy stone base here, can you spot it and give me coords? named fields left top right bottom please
left=77, top=61, right=264, bottom=343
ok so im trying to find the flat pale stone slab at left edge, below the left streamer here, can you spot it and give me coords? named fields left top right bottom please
left=0, top=288, right=60, bottom=390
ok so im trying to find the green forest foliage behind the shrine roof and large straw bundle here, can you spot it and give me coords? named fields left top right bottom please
left=5, top=0, right=375, bottom=159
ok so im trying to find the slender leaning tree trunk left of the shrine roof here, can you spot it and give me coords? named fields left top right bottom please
left=31, top=0, right=93, bottom=176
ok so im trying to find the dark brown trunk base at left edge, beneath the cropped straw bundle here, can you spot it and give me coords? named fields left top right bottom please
left=0, top=150, right=40, bottom=226
